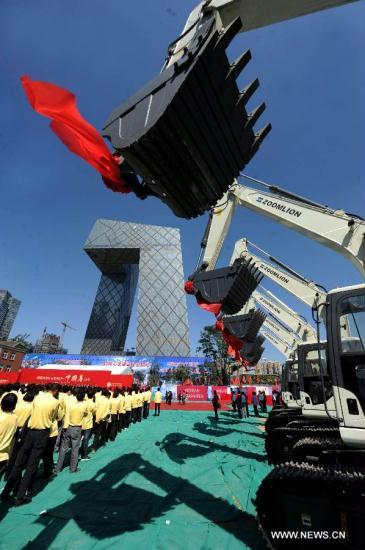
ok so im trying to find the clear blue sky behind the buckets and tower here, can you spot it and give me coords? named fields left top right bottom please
left=0, top=0, right=365, bottom=359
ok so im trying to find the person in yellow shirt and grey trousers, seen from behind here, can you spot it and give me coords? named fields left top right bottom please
left=55, top=389, right=88, bottom=475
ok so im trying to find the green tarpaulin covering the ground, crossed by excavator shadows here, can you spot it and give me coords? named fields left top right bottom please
left=0, top=411, right=269, bottom=550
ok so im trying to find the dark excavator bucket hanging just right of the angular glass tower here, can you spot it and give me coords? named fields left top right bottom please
left=190, top=259, right=263, bottom=315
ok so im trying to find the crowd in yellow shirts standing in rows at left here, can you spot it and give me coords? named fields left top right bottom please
left=0, top=384, right=162, bottom=506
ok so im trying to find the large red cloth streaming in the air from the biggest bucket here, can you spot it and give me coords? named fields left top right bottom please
left=20, top=76, right=131, bottom=193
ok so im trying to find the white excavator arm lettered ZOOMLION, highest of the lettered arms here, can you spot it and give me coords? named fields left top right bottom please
left=202, top=180, right=365, bottom=277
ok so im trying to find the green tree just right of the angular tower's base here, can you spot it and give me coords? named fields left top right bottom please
left=196, top=325, right=234, bottom=385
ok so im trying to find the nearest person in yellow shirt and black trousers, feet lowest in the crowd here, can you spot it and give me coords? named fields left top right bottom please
left=1, top=384, right=59, bottom=506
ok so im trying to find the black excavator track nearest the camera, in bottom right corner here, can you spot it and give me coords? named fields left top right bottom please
left=256, top=462, right=365, bottom=550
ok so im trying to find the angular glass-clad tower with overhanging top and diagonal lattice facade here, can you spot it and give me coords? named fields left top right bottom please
left=81, top=219, right=190, bottom=357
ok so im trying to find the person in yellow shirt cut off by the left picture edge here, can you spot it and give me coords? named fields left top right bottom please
left=0, top=393, right=18, bottom=478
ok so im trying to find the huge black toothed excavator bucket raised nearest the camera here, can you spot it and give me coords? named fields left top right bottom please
left=103, top=18, right=271, bottom=218
